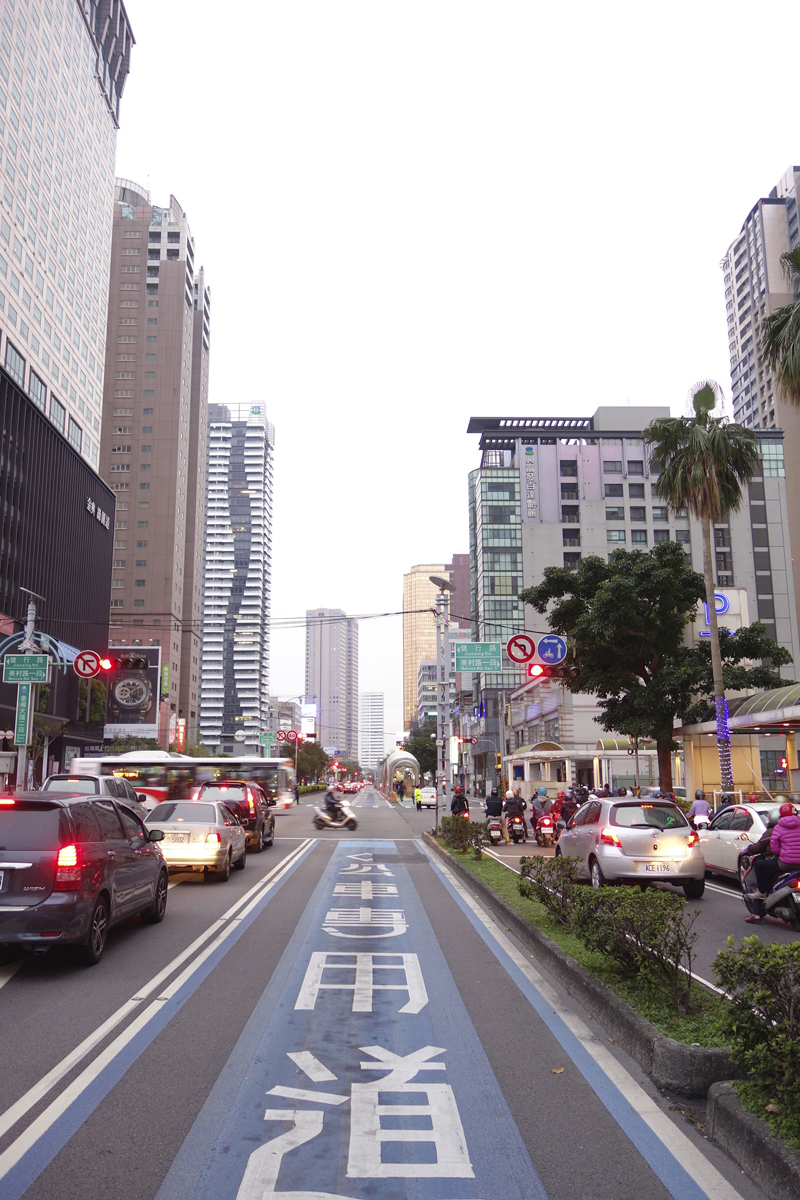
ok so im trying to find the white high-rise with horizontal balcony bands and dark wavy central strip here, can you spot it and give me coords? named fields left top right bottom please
left=200, top=404, right=275, bottom=754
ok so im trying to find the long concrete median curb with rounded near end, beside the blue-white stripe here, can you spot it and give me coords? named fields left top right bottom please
left=422, top=832, right=738, bottom=1099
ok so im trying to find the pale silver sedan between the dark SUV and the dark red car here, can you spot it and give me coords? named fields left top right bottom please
left=145, top=800, right=247, bottom=880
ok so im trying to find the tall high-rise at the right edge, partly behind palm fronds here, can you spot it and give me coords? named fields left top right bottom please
left=721, top=167, right=800, bottom=633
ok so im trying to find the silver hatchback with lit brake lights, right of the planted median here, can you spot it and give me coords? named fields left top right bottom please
left=555, top=797, right=705, bottom=900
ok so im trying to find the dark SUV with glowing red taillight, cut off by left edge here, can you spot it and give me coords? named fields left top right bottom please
left=0, top=792, right=168, bottom=965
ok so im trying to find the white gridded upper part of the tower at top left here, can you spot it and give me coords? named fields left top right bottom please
left=0, top=0, right=133, bottom=469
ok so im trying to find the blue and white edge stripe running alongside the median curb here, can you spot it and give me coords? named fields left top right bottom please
left=417, top=842, right=741, bottom=1200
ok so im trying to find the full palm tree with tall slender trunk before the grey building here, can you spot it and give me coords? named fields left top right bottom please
left=643, top=379, right=759, bottom=791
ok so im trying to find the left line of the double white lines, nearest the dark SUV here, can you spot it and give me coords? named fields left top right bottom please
left=0, top=838, right=314, bottom=1136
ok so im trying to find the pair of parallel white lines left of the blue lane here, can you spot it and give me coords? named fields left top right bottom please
left=0, top=838, right=313, bottom=1152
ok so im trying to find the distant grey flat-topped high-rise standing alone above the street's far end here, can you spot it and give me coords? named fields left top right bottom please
left=306, top=608, right=359, bottom=758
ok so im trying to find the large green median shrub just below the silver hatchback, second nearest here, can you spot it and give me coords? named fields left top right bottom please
left=573, top=888, right=697, bottom=1013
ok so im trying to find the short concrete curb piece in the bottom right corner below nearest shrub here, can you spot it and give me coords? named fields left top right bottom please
left=705, top=1080, right=800, bottom=1200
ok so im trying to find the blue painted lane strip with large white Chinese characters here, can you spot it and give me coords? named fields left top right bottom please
left=171, top=841, right=546, bottom=1200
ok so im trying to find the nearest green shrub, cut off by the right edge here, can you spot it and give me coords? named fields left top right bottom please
left=714, top=937, right=800, bottom=1146
